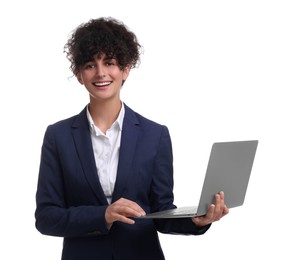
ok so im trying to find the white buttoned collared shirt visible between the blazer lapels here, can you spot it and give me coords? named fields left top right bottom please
left=87, top=103, right=125, bottom=204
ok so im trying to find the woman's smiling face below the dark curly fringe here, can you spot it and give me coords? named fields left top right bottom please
left=77, top=54, right=130, bottom=102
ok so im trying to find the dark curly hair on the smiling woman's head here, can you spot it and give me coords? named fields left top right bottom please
left=64, top=17, right=141, bottom=76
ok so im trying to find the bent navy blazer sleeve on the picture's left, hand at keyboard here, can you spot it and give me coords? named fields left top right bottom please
left=35, top=126, right=108, bottom=237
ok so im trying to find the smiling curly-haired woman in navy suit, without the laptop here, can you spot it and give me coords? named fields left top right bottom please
left=35, top=18, right=228, bottom=260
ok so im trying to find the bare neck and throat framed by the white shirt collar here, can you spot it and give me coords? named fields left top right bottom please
left=89, top=100, right=122, bottom=133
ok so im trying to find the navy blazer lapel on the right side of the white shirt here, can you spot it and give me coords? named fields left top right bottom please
left=112, top=105, right=139, bottom=202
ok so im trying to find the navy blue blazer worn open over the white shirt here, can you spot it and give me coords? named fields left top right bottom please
left=35, top=105, right=209, bottom=260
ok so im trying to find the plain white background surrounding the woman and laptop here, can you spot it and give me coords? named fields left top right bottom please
left=0, top=0, right=292, bottom=260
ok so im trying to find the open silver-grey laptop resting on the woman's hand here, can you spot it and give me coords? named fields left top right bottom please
left=141, top=140, right=258, bottom=218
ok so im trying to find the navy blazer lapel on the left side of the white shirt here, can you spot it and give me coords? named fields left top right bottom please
left=72, top=108, right=108, bottom=205
